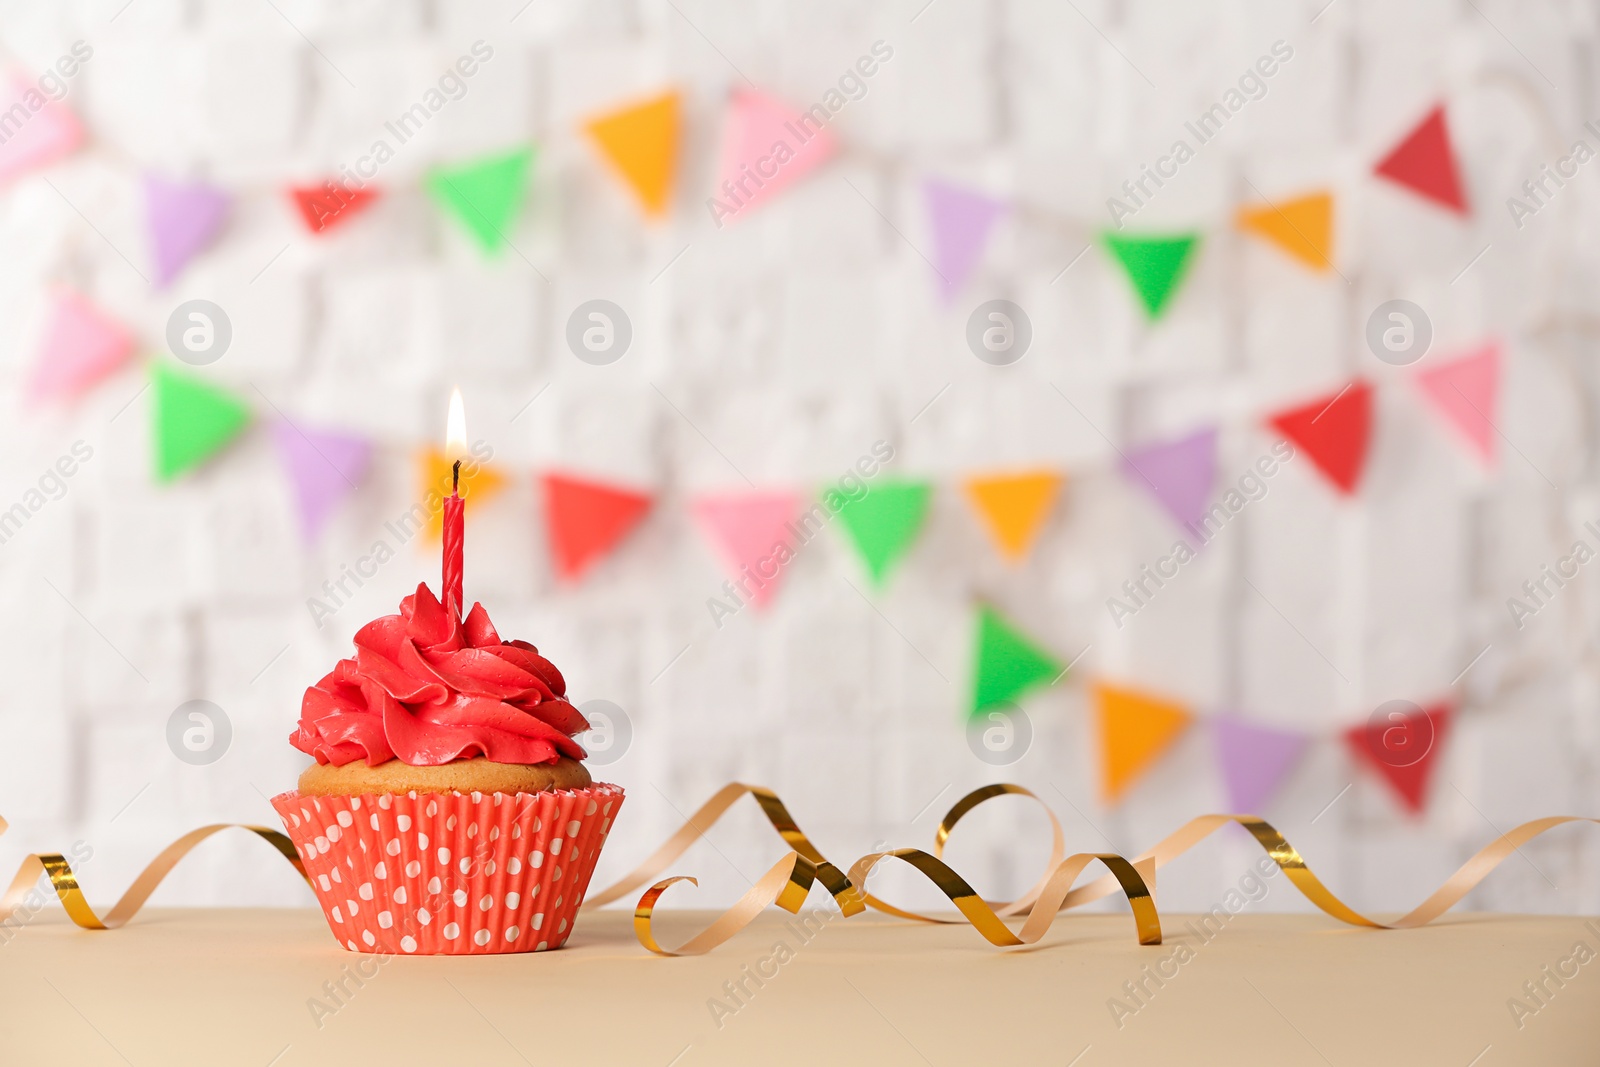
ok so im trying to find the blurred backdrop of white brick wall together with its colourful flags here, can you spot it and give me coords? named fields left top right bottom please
left=0, top=0, right=1600, bottom=912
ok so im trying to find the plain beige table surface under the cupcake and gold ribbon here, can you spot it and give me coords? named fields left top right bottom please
left=0, top=909, right=1600, bottom=1067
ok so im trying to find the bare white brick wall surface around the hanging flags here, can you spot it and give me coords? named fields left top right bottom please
left=0, top=0, right=1600, bottom=910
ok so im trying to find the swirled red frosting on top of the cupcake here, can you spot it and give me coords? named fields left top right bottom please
left=290, top=584, right=589, bottom=766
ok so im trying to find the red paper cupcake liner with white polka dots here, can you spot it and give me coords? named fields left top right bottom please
left=272, top=784, right=622, bottom=955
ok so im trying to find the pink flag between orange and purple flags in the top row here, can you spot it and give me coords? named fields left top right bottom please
left=710, top=90, right=838, bottom=226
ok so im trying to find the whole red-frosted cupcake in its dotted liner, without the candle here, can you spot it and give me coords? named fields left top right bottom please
left=272, top=584, right=622, bottom=955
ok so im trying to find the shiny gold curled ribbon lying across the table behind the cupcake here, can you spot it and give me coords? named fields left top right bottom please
left=0, top=782, right=1600, bottom=955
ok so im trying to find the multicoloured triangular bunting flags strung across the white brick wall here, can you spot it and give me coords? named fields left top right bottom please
left=12, top=68, right=1501, bottom=811
